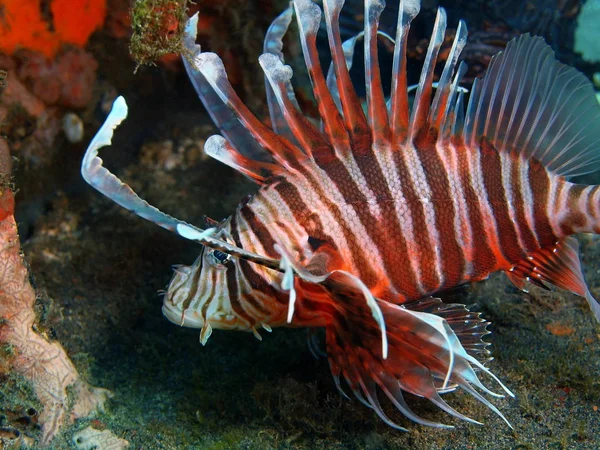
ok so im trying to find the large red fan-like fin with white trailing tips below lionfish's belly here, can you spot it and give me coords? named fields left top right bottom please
left=297, top=280, right=513, bottom=430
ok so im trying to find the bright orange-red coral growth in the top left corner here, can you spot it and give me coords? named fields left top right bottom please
left=0, top=0, right=106, bottom=58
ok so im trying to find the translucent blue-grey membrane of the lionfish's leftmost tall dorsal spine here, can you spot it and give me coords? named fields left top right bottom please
left=182, top=14, right=270, bottom=161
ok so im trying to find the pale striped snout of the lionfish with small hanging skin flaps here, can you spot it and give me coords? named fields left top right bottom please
left=162, top=249, right=244, bottom=343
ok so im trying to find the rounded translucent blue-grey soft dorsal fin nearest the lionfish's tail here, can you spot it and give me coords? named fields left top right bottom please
left=463, top=34, right=600, bottom=177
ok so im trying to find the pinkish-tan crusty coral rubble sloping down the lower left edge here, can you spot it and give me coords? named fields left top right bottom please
left=0, top=163, right=110, bottom=445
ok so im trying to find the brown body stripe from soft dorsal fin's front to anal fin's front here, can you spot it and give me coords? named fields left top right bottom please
left=481, top=139, right=527, bottom=263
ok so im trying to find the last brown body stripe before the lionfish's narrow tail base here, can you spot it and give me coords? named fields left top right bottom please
left=528, top=161, right=558, bottom=248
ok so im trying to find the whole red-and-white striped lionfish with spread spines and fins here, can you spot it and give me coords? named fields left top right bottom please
left=82, top=0, right=600, bottom=430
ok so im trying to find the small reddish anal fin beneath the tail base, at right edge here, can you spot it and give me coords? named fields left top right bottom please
left=506, top=236, right=600, bottom=322
